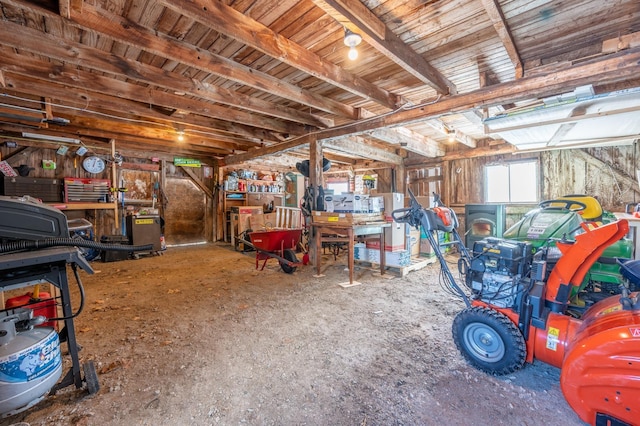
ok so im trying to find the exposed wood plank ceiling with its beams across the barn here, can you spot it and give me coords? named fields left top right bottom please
left=0, top=0, right=640, bottom=171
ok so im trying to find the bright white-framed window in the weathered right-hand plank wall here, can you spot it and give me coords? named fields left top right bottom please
left=484, top=160, right=538, bottom=203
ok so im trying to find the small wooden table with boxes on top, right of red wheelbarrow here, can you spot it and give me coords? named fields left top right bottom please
left=311, top=222, right=391, bottom=284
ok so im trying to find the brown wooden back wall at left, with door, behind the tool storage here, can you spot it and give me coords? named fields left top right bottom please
left=0, top=139, right=217, bottom=244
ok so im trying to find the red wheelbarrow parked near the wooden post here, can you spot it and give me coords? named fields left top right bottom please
left=244, top=229, right=302, bottom=274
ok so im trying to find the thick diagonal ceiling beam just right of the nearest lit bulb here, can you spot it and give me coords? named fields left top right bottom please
left=313, top=0, right=457, bottom=95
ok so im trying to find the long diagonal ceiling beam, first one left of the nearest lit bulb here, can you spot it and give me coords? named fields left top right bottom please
left=156, top=0, right=401, bottom=109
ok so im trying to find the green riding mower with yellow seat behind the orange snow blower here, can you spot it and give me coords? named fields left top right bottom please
left=503, top=195, right=637, bottom=309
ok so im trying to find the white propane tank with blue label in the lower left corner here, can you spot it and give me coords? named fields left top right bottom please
left=0, top=319, right=62, bottom=418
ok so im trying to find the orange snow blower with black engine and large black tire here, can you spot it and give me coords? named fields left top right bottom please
left=393, top=191, right=640, bottom=426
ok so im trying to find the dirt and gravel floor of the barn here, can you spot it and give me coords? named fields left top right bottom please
left=0, top=244, right=583, bottom=426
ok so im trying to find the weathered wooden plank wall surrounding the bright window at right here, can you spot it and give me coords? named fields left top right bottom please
left=408, top=143, right=640, bottom=236
